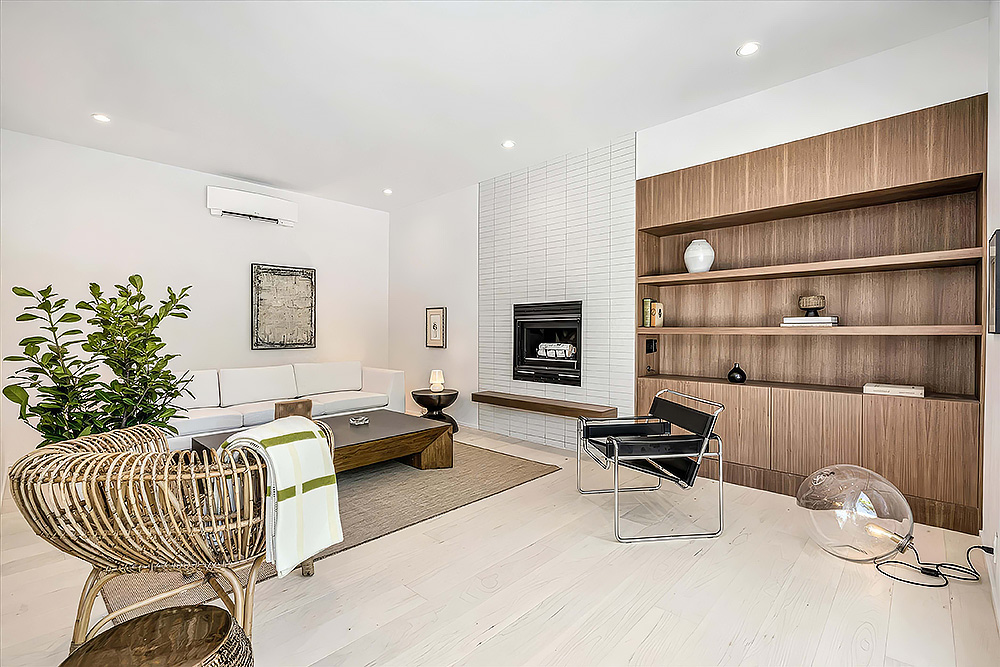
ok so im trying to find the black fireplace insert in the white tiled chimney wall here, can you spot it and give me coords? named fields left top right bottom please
left=514, top=301, right=583, bottom=387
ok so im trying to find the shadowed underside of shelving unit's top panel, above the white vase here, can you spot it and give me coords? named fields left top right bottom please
left=639, top=173, right=983, bottom=236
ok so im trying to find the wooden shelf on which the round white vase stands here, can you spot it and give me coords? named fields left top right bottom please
left=638, top=247, right=983, bottom=287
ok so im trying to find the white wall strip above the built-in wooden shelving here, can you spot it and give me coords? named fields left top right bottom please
left=636, top=19, right=996, bottom=178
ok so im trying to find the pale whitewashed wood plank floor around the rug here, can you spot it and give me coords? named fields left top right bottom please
left=0, top=428, right=1000, bottom=666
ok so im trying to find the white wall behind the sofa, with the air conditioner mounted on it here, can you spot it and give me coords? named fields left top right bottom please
left=0, top=127, right=390, bottom=464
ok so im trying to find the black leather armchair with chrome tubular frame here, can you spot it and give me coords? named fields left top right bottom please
left=576, top=389, right=725, bottom=543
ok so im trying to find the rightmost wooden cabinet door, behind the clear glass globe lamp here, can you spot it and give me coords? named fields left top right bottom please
left=861, top=395, right=980, bottom=507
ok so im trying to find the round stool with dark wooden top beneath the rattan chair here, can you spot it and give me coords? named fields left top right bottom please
left=61, top=605, right=253, bottom=667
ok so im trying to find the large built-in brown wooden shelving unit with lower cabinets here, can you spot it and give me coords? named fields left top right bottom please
left=636, top=95, right=986, bottom=532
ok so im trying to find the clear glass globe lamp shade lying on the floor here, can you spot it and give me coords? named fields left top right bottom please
left=795, top=465, right=913, bottom=561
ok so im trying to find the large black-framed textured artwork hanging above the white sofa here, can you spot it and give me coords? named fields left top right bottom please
left=250, top=264, right=316, bottom=350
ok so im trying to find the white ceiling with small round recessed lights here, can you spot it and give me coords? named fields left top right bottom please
left=0, top=0, right=988, bottom=210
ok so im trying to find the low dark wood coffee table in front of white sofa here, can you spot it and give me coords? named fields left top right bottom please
left=191, top=410, right=454, bottom=472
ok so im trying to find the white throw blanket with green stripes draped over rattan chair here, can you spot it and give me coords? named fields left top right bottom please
left=222, top=417, right=344, bottom=577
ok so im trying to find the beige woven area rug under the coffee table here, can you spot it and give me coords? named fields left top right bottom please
left=101, top=442, right=559, bottom=621
